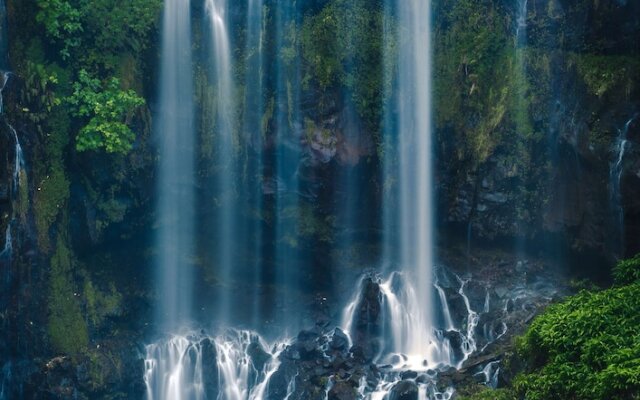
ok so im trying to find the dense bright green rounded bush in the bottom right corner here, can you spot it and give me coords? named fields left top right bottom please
left=514, top=274, right=640, bottom=400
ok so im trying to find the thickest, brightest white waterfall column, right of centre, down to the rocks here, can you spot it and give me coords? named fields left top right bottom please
left=384, top=0, right=437, bottom=368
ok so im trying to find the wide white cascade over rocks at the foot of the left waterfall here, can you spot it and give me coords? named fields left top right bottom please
left=145, top=331, right=286, bottom=400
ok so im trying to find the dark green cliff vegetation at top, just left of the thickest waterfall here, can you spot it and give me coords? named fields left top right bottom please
left=300, top=0, right=395, bottom=124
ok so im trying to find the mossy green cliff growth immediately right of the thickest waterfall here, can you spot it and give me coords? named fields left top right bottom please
left=434, top=0, right=512, bottom=164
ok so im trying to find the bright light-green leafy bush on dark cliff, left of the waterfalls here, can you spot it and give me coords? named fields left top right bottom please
left=67, top=70, right=145, bottom=153
